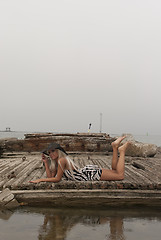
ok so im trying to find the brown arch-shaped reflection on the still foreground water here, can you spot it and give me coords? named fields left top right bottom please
left=38, top=210, right=125, bottom=240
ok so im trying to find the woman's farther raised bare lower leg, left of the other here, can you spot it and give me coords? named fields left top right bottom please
left=111, top=136, right=126, bottom=170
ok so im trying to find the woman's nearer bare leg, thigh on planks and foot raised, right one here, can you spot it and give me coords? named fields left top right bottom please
left=100, top=142, right=129, bottom=181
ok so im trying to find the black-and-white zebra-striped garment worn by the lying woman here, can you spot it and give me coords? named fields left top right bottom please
left=63, top=165, right=102, bottom=181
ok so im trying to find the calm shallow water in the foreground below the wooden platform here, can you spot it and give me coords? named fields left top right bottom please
left=0, top=208, right=161, bottom=240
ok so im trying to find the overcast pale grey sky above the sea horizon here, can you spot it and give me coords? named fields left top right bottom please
left=0, top=0, right=161, bottom=134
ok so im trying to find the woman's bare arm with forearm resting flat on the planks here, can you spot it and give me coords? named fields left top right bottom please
left=30, top=158, right=66, bottom=183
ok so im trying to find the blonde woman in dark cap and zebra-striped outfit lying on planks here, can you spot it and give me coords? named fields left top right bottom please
left=30, top=136, right=129, bottom=183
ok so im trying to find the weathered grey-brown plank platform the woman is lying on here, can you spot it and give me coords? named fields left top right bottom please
left=0, top=148, right=161, bottom=207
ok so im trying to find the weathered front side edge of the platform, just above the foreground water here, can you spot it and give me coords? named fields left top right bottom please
left=11, top=189, right=161, bottom=207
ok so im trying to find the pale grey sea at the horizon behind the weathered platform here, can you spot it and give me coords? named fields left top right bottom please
left=0, top=131, right=161, bottom=147
